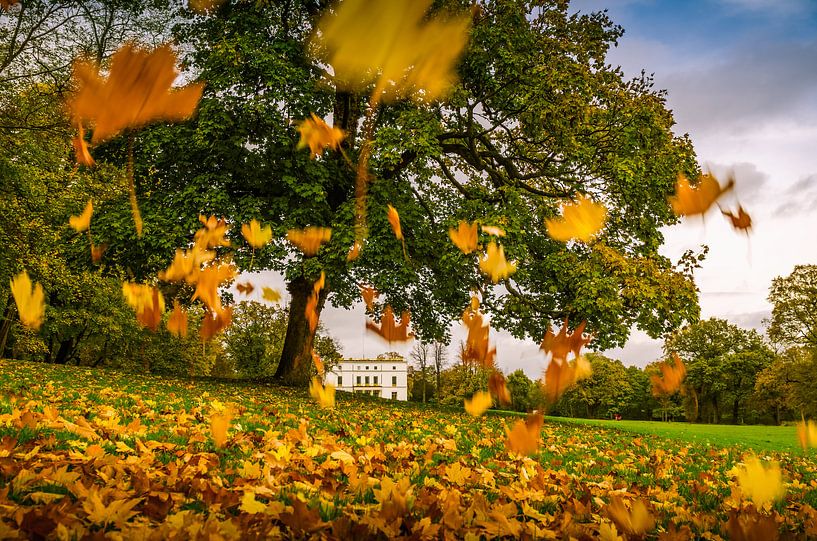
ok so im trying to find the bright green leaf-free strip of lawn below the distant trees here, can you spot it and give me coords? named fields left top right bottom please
left=548, top=417, right=800, bottom=452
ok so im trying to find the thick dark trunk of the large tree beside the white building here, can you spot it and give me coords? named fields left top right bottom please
left=273, top=278, right=327, bottom=387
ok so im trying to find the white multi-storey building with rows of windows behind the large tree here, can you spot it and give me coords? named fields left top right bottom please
left=325, top=358, right=408, bottom=400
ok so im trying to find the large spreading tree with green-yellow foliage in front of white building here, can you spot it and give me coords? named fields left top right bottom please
left=103, top=0, right=698, bottom=383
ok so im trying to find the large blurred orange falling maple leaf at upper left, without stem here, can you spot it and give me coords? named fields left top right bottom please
left=68, top=44, right=204, bottom=143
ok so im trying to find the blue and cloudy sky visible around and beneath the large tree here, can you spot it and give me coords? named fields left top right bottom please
left=239, top=0, right=817, bottom=378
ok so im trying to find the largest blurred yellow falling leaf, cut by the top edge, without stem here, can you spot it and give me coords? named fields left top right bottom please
left=316, top=0, right=470, bottom=101
